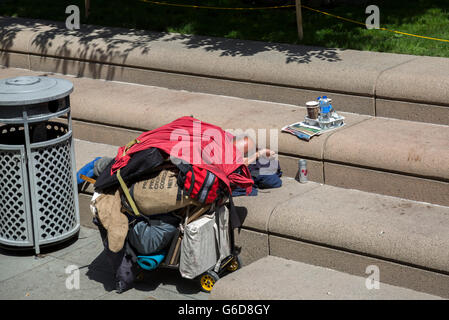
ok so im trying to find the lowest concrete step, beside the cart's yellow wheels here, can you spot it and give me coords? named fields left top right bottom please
left=211, top=256, right=441, bottom=300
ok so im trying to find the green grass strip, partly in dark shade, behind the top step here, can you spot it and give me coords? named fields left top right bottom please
left=0, top=0, right=449, bottom=57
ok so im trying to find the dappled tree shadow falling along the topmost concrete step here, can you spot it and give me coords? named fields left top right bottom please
left=0, top=17, right=341, bottom=80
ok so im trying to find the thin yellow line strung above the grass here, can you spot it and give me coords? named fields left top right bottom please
left=139, top=0, right=449, bottom=42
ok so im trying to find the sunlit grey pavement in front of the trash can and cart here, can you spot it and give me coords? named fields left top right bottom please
left=0, top=226, right=209, bottom=300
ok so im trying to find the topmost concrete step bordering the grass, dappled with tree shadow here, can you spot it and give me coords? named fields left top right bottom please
left=0, top=17, right=449, bottom=125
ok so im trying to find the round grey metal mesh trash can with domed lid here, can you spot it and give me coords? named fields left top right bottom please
left=0, top=76, right=80, bottom=254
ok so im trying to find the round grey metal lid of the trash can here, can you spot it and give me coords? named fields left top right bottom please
left=0, top=76, right=73, bottom=107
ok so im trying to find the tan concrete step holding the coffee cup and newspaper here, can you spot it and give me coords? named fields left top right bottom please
left=1, top=68, right=449, bottom=206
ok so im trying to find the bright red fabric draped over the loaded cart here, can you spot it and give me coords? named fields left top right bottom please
left=111, top=117, right=254, bottom=203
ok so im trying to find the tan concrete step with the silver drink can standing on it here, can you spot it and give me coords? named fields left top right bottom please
left=75, top=139, right=449, bottom=297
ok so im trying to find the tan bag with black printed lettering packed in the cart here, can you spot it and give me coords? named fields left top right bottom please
left=121, top=169, right=197, bottom=215
